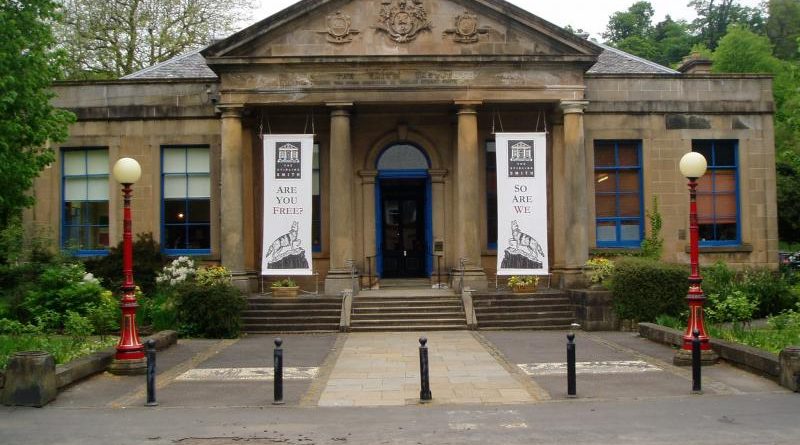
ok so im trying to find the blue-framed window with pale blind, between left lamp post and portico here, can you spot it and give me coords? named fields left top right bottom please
left=161, top=146, right=211, bottom=254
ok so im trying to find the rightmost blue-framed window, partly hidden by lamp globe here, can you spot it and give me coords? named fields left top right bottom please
left=692, top=140, right=739, bottom=246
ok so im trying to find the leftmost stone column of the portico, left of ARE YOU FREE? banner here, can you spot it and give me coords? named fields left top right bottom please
left=220, top=106, right=245, bottom=280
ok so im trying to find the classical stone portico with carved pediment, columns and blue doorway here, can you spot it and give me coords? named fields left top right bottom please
left=203, top=0, right=599, bottom=294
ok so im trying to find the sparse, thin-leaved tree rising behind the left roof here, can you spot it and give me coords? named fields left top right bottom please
left=58, top=0, right=253, bottom=79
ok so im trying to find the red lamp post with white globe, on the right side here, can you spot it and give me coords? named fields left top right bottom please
left=673, top=152, right=717, bottom=366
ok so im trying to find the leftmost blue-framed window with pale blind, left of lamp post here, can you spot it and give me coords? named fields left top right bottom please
left=61, top=148, right=109, bottom=255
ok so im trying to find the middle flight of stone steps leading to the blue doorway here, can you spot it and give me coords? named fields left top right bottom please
left=350, top=283, right=467, bottom=332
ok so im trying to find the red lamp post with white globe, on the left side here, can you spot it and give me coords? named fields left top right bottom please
left=109, top=158, right=147, bottom=374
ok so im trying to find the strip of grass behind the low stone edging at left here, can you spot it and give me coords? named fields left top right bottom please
left=0, top=334, right=119, bottom=369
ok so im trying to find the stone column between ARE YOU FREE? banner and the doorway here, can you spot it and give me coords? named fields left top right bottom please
left=325, top=103, right=358, bottom=295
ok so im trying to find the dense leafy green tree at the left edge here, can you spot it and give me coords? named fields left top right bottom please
left=0, top=0, right=75, bottom=228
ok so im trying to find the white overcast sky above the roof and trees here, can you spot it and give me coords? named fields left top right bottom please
left=252, top=0, right=761, bottom=39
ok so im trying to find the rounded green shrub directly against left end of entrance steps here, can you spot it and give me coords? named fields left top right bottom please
left=175, top=281, right=245, bottom=338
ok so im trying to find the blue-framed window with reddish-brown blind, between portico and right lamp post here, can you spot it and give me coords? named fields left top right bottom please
left=594, top=141, right=643, bottom=247
